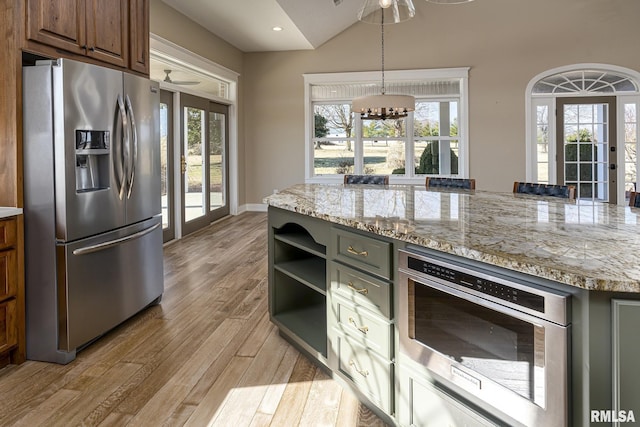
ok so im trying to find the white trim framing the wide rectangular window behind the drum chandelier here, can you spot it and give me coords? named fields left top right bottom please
left=303, top=67, right=469, bottom=184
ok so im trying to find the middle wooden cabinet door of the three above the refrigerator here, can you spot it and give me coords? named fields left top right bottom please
left=86, top=0, right=129, bottom=68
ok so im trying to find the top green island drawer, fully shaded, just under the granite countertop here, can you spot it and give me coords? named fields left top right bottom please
left=332, top=228, right=393, bottom=279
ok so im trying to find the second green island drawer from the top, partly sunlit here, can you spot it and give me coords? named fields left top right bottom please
left=331, top=262, right=393, bottom=319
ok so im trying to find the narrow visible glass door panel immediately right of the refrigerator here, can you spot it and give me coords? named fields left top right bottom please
left=160, top=90, right=175, bottom=242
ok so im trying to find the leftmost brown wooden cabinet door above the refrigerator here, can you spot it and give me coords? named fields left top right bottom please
left=27, top=0, right=87, bottom=55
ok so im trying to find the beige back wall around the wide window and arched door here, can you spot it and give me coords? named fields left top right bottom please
left=242, top=0, right=640, bottom=203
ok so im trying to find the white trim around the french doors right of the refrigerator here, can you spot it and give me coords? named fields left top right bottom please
left=149, top=34, right=245, bottom=224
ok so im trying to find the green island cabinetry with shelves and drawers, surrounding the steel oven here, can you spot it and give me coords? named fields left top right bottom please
left=268, top=206, right=640, bottom=427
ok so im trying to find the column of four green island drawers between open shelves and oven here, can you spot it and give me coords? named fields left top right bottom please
left=327, top=226, right=395, bottom=415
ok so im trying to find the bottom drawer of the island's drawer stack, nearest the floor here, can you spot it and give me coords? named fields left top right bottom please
left=338, top=336, right=393, bottom=414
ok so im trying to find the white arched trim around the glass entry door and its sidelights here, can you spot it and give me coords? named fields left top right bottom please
left=525, top=63, right=640, bottom=205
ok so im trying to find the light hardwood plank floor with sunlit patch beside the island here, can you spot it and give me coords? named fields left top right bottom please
left=0, top=213, right=383, bottom=427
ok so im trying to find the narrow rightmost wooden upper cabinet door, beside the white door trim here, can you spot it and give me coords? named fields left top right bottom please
left=129, top=0, right=149, bottom=75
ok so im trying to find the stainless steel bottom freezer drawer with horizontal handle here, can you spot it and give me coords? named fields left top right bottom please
left=57, top=217, right=164, bottom=352
